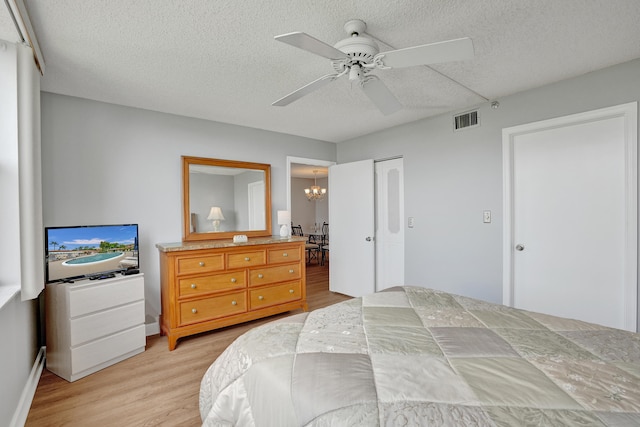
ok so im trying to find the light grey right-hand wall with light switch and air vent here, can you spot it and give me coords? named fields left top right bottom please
left=338, top=60, right=640, bottom=320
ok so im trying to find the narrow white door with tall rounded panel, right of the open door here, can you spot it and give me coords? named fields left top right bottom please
left=375, top=158, right=404, bottom=291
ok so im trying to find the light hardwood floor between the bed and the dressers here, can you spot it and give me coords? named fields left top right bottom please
left=26, top=264, right=349, bottom=427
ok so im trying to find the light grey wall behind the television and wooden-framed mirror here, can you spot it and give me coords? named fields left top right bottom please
left=42, top=92, right=336, bottom=316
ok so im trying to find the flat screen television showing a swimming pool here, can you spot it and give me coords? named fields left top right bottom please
left=44, top=224, right=140, bottom=283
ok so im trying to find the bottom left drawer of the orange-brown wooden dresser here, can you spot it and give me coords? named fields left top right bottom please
left=180, top=291, right=247, bottom=325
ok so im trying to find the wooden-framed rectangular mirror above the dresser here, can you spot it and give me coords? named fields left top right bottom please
left=182, top=156, right=271, bottom=241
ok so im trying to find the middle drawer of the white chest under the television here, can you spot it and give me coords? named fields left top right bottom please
left=70, top=301, right=144, bottom=347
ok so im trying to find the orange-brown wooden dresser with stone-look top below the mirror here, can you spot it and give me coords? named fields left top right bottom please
left=156, top=237, right=308, bottom=350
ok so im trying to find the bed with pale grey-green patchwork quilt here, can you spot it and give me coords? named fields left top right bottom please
left=199, top=286, right=640, bottom=427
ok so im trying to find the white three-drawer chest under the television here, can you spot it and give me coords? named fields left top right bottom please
left=45, top=274, right=146, bottom=381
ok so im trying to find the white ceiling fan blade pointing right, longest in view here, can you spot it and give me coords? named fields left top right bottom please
left=374, top=37, right=473, bottom=68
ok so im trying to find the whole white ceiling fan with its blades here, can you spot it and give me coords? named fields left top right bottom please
left=271, top=19, right=473, bottom=115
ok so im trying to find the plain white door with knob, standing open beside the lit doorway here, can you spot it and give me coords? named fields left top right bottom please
left=329, top=160, right=375, bottom=297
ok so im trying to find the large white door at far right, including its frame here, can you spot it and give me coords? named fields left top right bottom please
left=503, top=105, right=637, bottom=331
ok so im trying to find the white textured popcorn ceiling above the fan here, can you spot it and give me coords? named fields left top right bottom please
left=0, top=0, right=640, bottom=142
